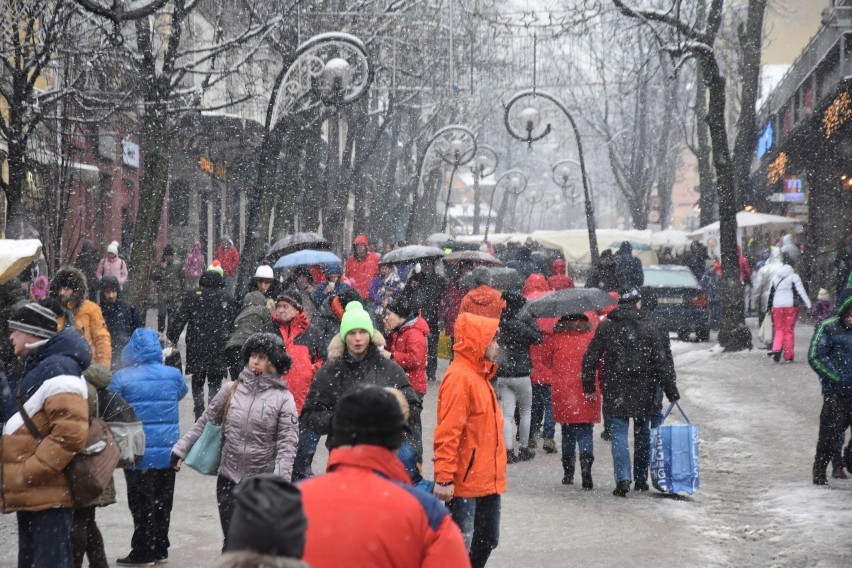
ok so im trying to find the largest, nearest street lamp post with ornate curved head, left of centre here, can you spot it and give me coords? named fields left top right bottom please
left=239, top=32, right=373, bottom=289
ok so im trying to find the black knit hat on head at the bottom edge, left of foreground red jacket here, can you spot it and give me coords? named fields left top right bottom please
left=225, top=474, right=308, bottom=558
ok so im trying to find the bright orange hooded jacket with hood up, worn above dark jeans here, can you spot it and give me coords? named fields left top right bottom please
left=433, top=313, right=506, bottom=498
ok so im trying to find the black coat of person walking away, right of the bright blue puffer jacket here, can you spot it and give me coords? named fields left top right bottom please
left=168, top=271, right=238, bottom=375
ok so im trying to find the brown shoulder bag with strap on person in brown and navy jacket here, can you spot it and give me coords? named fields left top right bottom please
left=17, top=389, right=121, bottom=507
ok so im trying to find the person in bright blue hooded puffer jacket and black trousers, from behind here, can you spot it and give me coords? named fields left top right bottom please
left=108, top=328, right=188, bottom=566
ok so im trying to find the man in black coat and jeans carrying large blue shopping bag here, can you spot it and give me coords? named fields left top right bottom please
left=583, top=288, right=680, bottom=497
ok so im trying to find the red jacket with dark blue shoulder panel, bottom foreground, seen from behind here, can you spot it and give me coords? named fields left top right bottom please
left=299, top=445, right=470, bottom=568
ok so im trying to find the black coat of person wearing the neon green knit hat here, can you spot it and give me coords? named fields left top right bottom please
left=300, top=333, right=423, bottom=435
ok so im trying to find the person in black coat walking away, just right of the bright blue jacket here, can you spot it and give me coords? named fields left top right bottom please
left=166, top=266, right=236, bottom=420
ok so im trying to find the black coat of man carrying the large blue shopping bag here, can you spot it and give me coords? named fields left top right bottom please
left=583, top=305, right=680, bottom=418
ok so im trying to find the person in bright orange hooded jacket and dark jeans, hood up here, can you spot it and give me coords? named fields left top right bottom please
left=433, top=313, right=507, bottom=568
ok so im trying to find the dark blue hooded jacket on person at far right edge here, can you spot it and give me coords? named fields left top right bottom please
left=808, top=288, right=852, bottom=396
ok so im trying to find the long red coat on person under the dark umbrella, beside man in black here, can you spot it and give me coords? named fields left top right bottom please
left=542, top=312, right=601, bottom=424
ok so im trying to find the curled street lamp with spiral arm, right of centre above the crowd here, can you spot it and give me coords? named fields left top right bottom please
left=503, top=89, right=598, bottom=263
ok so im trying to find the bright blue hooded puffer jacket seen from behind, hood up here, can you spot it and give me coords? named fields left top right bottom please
left=109, top=328, right=189, bottom=469
